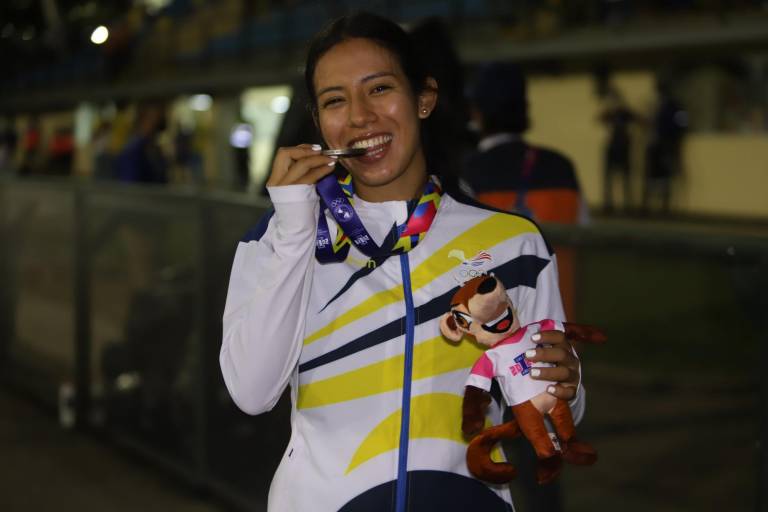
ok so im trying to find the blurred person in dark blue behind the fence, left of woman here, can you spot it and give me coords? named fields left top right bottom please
left=116, top=103, right=168, bottom=183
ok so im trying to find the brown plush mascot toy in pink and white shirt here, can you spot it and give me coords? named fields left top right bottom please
left=440, top=275, right=605, bottom=484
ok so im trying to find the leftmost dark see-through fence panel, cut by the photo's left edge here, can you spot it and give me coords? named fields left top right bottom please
left=0, top=183, right=76, bottom=403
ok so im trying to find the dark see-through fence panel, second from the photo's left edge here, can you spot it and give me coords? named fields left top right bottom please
left=87, top=187, right=202, bottom=467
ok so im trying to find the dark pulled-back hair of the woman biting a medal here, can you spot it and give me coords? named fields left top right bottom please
left=304, top=12, right=427, bottom=116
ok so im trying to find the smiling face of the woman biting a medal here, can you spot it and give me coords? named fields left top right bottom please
left=314, top=38, right=437, bottom=201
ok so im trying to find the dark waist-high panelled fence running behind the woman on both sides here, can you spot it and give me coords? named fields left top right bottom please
left=0, top=177, right=768, bottom=512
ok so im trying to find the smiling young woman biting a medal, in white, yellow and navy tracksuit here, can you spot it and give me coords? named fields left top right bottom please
left=225, top=14, right=583, bottom=512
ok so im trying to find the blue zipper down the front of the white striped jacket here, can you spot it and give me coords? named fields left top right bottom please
left=395, top=254, right=416, bottom=512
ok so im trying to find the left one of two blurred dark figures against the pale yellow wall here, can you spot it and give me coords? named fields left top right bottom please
left=600, top=85, right=637, bottom=213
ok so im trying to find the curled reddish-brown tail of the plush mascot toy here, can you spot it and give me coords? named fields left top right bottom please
left=467, top=421, right=521, bottom=484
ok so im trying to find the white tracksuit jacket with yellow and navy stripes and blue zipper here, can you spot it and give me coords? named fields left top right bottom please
left=220, top=185, right=584, bottom=512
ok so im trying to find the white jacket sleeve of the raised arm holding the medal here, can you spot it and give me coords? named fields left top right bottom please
left=219, top=185, right=319, bottom=414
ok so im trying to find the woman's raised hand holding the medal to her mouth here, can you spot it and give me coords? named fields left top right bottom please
left=267, top=144, right=338, bottom=187
